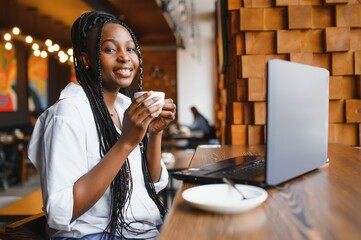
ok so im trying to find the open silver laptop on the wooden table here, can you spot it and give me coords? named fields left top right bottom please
left=171, top=59, right=329, bottom=187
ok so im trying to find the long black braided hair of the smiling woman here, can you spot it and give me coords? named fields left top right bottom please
left=71, top=11, right=167, bottom=236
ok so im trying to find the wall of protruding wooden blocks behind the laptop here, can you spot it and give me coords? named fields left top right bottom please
left=215, top=0, right=361, bottom=146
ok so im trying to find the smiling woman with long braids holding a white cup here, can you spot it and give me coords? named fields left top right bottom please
left=28, top=11, right=176, bottom=239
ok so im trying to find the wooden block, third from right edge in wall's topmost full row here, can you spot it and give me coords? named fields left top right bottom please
left=288, top=5, right=312, bottom=29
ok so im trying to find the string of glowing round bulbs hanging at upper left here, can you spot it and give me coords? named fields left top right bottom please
left=0, top=27, right=73, bottom=63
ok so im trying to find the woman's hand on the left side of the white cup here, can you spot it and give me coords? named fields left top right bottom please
left=119, top=91, right=164, bottom=147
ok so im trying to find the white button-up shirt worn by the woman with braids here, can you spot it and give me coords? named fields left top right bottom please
left=28, top=83, right=168, bottom=238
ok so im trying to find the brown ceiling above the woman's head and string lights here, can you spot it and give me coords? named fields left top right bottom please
left=0, top=0, right=177, bottom=48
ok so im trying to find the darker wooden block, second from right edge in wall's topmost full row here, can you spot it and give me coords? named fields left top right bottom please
left=312, top=6, right=333, bottom=28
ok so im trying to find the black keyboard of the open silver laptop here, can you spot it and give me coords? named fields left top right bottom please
left=211, top=159, right=265, bottom=178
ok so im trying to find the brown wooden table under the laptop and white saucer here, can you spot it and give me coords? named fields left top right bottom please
left=159, top=144, right=361, bottom=240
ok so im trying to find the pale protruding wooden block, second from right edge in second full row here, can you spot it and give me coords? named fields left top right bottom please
left=325, top=27, right=350, bottom=52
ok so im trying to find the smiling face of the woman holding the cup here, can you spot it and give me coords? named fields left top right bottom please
left=86, top=23, right=139, bottom=91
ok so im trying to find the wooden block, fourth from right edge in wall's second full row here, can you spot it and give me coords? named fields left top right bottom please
left=277, top=30, right=302, bottom=53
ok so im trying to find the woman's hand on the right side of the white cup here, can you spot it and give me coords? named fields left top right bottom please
left=149, top=98, right=176, bottom=133
